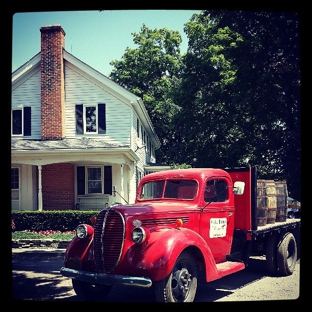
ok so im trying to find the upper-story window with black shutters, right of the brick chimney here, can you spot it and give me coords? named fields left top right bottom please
left=76, top=103, right=106, bottom=134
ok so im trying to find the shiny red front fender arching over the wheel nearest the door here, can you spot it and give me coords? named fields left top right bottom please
left=132, top=228, right=218, bottom=281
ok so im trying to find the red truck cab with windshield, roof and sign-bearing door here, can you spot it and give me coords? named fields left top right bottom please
left=136, top=169, right=235, bottom=263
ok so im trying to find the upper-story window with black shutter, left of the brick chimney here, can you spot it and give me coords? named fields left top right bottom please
left=11, top=107, right=31, bottom=136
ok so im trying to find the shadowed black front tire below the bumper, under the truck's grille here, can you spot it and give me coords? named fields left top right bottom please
left=72, top=279, right=113, bottom=301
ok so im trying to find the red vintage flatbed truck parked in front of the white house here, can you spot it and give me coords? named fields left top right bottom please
left=60, top=167, right=301, bottom=302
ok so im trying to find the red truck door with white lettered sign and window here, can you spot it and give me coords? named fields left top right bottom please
left=199, top=177, right=234, bottom=263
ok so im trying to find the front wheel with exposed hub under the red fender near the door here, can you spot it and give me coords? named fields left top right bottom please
left=154, top=252, right=197, bottom=302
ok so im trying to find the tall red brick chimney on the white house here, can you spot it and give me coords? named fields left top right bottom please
left=40, top=25, right=65, bottom=140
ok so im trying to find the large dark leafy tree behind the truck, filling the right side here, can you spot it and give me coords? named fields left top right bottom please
left=175, top=11, right=301, bottom=199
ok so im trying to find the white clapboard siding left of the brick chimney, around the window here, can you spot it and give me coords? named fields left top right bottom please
left=12, top=68, right=41, bottom=139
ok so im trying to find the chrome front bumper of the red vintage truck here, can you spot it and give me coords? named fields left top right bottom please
left=61, top=267, right=152, bottom=287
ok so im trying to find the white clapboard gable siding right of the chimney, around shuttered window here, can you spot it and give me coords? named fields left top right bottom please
left=65, top=66, right=132, bottom=145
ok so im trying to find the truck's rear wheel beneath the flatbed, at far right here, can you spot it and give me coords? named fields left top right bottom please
left=277, top=232, right=297, bottom=276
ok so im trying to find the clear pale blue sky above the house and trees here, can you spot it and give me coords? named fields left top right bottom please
left=12, top=10, right=200, bottom=76
